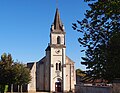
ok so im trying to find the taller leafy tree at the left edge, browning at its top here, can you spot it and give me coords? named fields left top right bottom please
left=0, top=53, right=15, bottom=93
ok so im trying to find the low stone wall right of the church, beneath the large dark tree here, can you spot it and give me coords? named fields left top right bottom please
left=75, top=85, right=112, bottom=93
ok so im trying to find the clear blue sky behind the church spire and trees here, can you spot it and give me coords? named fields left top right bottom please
left=0, top=0, right=88, bottom=70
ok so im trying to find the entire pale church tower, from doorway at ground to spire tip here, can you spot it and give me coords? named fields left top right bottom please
left=49, top=8, right=66, bottom=92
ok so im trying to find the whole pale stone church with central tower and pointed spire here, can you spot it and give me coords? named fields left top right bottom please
left=27, top=8, right=76, bottom=93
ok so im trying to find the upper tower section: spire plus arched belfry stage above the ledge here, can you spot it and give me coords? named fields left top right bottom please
left=50, top=8, right=65, bottom=47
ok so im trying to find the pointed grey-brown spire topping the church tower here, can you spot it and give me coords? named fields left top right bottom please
left=52, top=8, right=64, bottom=32
